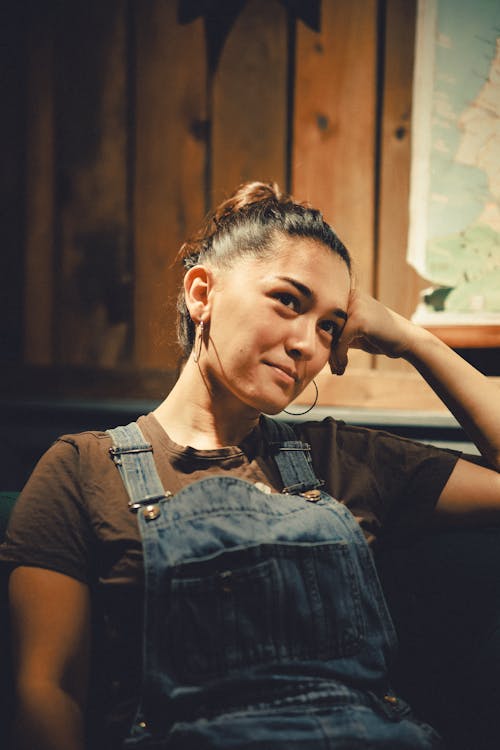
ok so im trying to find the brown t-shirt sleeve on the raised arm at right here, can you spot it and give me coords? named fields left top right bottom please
left=296, top=418, right=460, bottom=540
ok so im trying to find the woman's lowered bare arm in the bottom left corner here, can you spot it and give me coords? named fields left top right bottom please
left=9, top=566, right=90, bottom=750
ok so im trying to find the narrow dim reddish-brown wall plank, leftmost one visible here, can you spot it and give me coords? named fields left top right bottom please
left=24, top=4, right=55, bottom=365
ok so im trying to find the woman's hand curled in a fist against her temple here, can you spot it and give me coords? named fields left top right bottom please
left=330, top=289, right=422, bottom=375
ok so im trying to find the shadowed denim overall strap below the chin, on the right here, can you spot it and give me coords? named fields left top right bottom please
left=262, top=417, right=324, bottom=495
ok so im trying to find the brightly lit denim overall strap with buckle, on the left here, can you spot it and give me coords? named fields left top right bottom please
left=106, top=422, right=170, bottom=511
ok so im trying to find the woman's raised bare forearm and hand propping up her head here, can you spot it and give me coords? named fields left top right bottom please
left=330, top=291, right=500, bottom=472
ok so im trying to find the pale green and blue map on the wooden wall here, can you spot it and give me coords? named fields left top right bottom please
left=408, top=0, right=500, bottom=325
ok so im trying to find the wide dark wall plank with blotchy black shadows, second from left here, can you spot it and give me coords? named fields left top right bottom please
left=56, top=0, right=131, bottom=366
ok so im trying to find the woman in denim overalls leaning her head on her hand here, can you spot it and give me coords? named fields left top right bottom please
left=1, top=183, right=500, bottom=750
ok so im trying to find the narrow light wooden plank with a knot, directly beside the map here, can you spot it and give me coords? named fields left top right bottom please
left=375, top=0, right=426, bottom=372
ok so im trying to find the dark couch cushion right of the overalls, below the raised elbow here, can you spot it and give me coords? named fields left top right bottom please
left=377, top=527, right=500, bottom=750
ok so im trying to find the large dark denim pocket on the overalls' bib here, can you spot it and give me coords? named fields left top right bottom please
left=160, top=541, right=364, bottom=682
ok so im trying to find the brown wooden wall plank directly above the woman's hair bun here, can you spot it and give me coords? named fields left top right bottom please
left=211, top=0, right=288, bottom=205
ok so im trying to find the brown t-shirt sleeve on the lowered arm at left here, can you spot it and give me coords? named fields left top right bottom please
left=0, top=436, right=92, bottom=583
